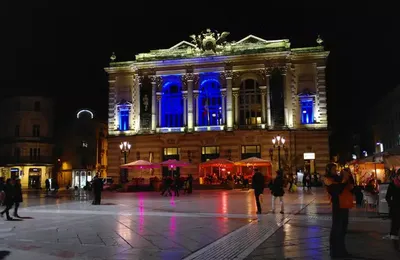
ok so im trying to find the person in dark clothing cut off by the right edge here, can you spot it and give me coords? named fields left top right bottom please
left=386, top=169, right=400, bottom=251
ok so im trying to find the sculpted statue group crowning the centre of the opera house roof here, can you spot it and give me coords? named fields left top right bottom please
left=190, top=29, right=230, bottom=54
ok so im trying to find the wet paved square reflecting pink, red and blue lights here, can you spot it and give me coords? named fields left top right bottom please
left=0, top=190, right=399, bottom=260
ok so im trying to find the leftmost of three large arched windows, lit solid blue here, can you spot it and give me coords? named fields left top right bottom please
left=161, top=82, right=183, bottom=127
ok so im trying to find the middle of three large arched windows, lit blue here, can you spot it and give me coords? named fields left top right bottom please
left=197, top=79, right=222, bottom=126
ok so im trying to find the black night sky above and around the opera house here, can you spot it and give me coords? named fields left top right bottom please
left=0, top=1, right=400, bottom=157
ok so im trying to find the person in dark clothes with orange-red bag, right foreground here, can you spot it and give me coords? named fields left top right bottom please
left=324, top=163, right=354, bottom=257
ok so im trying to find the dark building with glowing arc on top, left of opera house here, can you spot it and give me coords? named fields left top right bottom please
left=56, top=109, right=107, bottom=188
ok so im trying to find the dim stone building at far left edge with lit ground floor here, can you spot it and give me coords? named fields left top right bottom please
left=0, top=96, right=54, bottom=188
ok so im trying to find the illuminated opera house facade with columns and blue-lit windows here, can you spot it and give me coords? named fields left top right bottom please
left=105, top=29, right=329, bottom=180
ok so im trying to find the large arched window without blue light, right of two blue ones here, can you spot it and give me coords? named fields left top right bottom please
left=239, top=79, right=261, bottom=125
